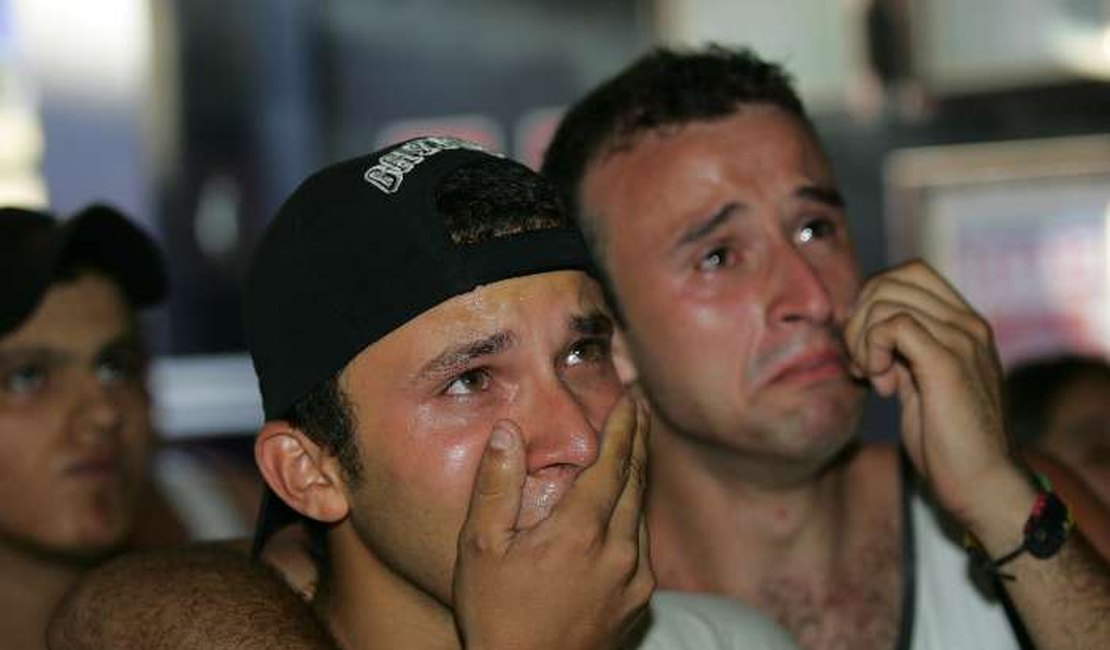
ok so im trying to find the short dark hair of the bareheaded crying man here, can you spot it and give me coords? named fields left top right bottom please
left=542, top=45, right=811, bottom=317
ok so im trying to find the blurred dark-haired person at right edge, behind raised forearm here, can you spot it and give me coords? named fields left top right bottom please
left=1006, top=348, right=1110, bottom=506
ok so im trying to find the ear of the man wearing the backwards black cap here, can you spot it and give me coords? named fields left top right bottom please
left=254, top=420, right=351, bottom=524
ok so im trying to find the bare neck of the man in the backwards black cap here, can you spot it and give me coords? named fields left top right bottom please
left=315, top=524, right=461, bottom=650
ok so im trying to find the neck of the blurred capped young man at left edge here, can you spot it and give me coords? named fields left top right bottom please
left=0, top=542, right=84, bottom=648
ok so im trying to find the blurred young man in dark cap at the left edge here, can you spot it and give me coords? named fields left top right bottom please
left=0, top=205, right=173, bottom=648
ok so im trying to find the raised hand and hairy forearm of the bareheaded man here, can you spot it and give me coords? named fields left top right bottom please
left=845, top=262, right=1110, bottom=650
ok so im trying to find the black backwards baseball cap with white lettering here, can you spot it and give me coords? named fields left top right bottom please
left=243, top=136, right=596, bottom=555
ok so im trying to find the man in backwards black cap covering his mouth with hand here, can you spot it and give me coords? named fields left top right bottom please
left=52, top=138, right=793, bottom=650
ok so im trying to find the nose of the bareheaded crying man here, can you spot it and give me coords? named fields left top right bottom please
left=768, top=242, right=834, bottom=325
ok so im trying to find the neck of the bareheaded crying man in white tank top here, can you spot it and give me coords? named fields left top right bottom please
left=648, top=420, right=850, bottom=600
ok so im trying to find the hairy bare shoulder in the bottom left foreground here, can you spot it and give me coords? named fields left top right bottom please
left=48, top=546, right=337, bottom=650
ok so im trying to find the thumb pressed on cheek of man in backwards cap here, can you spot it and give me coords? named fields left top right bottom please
left=460, top=420, right=525, bottom=550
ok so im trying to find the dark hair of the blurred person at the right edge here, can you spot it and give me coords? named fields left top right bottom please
left=1006, top=354, right=1110, bottom=444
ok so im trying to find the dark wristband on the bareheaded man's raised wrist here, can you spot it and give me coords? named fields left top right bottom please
left=963, top=474, right=1074, bottom=580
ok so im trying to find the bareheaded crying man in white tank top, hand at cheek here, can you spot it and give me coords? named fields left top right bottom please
left=543, top=47, right=1110, bottom=650
